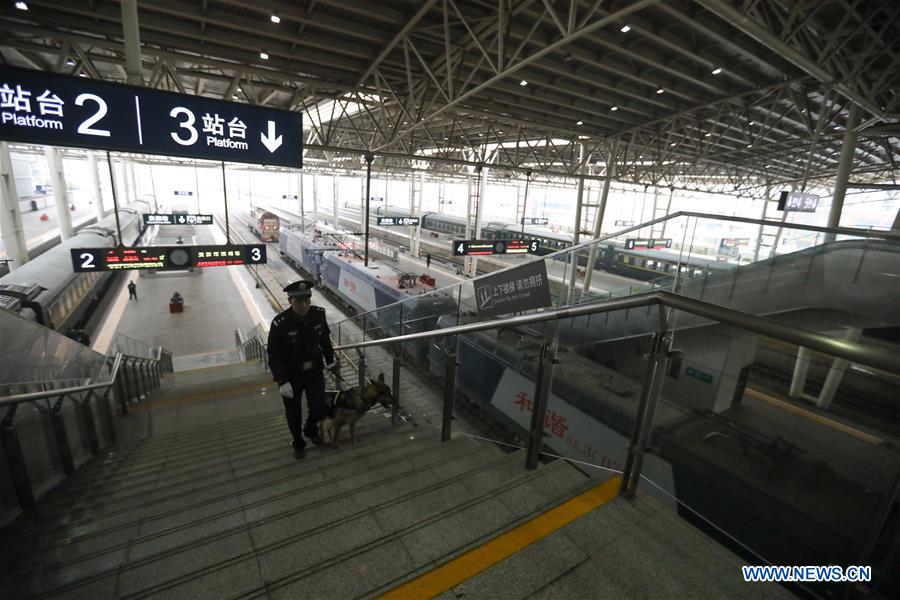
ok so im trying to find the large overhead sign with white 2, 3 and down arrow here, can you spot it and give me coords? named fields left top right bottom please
left=0, top=66, right=303, bottom=168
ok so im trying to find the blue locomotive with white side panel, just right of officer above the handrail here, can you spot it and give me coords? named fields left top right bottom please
left=321, top=251, right=457, bottom=364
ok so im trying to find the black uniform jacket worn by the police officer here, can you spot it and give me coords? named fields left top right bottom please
left=268, top=306, right=334, bottom=385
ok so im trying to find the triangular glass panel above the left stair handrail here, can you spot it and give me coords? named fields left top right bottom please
left=0, top=311, right=106, bottom=396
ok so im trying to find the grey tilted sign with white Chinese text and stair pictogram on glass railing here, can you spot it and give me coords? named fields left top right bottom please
left=475, top=260, right=550, bottom=318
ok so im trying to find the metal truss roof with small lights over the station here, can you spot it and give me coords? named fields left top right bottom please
left=0, top=0, right=900, bottom=191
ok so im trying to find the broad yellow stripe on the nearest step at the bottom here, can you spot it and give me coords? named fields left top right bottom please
left=381, top=477, right=622, bottom=600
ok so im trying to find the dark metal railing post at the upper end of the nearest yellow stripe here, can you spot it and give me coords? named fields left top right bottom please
left=619, top=305, right=670, bottom=498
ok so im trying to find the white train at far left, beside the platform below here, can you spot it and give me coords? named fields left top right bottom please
left=0, top=200, right=152, bottom=332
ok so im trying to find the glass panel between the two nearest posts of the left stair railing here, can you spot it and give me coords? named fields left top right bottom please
left=15, top=400, right=63, bottom=496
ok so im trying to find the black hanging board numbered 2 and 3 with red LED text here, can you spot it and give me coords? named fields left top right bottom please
left=70, top=244, right=266, bottom=273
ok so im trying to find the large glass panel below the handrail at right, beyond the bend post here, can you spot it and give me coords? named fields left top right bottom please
left=641, top=315, right=900, bottom=597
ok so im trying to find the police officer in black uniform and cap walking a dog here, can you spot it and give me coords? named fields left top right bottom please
left=268, top=281, right=334, bottom=459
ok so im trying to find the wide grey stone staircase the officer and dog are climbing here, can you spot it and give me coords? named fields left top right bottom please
left=0, top=360, right=791, bottom=599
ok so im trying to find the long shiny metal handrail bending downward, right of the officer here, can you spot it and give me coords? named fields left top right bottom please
left=335, top=291, right=900, bottom=374
